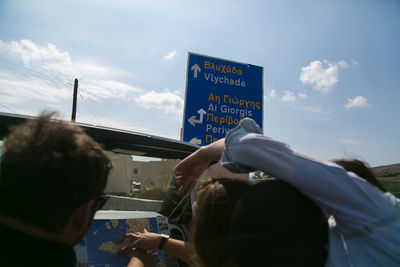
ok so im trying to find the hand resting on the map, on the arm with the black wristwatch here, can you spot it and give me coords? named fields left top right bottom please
left=121, top=229, right=161, bottom=252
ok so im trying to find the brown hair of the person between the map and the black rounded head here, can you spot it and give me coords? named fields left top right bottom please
left=191, top=178, right=250, bottom=267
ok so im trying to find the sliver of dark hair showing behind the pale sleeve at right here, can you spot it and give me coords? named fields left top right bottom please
left=333, top=159, right=387, bottom=192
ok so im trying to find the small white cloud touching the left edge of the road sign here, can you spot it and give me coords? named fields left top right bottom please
left=135, top=90, right=183, bottom=114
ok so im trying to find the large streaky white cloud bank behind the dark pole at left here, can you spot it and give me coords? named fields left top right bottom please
left=0, top=40, right=142, bottom=104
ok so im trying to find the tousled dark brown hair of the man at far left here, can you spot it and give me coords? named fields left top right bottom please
left=0, top=113, right=111, bottom=232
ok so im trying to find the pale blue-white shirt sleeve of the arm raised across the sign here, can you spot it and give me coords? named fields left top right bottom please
left=221, top=120, right=399, bottom=229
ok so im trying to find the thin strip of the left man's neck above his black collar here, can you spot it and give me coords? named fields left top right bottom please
left=0, top=215, right=69, bottom=243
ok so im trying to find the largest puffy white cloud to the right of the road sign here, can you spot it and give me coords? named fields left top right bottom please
left=300, top=60, right=347, bottom=93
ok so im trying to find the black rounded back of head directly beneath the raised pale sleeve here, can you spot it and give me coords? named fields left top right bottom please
left=230, top=180, right=328, bottom=267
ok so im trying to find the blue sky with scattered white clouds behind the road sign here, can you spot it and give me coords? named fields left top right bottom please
left=0, top=0, right=400, bottom=166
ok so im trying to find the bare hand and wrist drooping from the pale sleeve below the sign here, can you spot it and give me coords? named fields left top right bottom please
left=174, top=139, right=225, bottom=194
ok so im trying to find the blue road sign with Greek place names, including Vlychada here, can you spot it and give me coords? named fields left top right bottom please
left=182, top=53, right=263, bottom=146
